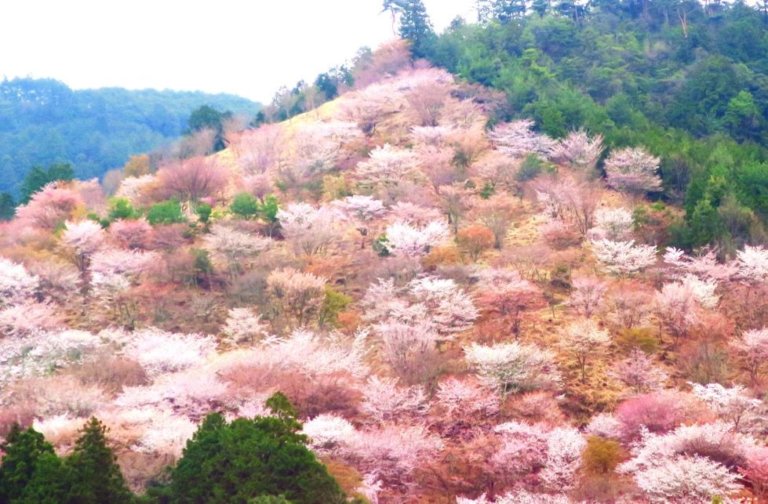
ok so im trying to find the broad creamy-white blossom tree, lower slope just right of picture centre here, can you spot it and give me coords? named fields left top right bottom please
left=464, top=341, right=560, bottom=396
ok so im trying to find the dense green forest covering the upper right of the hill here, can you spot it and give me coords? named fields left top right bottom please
left=425, top=0, right=768, bottom=250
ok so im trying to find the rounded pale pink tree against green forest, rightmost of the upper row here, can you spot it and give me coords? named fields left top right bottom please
left=605, top=147, right=661, bottom=194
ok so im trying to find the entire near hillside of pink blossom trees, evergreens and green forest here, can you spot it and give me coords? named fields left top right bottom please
left=0, top=0, right=768, bottom=504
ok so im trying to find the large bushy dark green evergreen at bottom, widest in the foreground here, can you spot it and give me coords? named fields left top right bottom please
left=166, top=394, right=345, bottom=504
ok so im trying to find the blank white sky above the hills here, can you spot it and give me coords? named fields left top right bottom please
left=0, top=0, right=474, bottom=102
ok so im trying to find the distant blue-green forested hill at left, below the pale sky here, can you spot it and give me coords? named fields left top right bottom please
left=0, top=79, right=259, bottom=196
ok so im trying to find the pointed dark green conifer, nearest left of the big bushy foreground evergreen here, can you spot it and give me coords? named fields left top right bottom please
left=66, top=418, right=133, bottom=504
